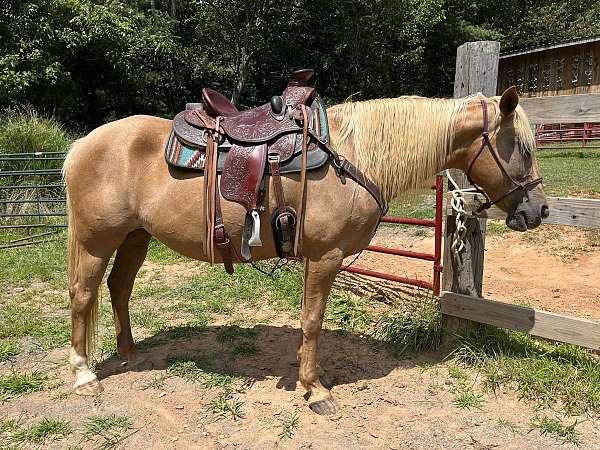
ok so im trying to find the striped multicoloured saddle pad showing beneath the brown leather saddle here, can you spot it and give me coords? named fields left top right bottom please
left=165, top=131, right=329, bottom=173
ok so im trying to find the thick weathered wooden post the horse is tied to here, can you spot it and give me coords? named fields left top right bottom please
left=442, top=41, right=500, bottom=332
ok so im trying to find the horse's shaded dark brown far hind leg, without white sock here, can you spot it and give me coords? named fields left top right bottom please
left=107, top=229, right=151, bottom=362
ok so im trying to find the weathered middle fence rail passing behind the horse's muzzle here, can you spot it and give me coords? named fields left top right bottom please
left=446, top=193, right=600, bottom=228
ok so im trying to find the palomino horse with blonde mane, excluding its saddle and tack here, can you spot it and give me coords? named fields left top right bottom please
left=64, top=88, right=548, bottom=414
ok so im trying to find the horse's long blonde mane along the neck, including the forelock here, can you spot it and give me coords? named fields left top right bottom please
left=327, top=94, right=535, bottom=199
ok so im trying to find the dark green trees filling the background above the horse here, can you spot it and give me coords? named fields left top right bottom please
left=0, top=0, right=600, bottom=127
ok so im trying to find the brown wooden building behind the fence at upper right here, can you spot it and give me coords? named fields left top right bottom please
left=498, top=37, right=600, bottom=97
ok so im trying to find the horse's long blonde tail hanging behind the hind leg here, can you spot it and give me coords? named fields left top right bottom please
left=62, top=141, right=99, bottom=358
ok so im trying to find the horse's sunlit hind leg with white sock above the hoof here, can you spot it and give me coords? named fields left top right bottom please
left=69, top=239, right=112, bottom=395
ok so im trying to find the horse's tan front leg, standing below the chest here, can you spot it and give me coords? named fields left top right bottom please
left=299, top=250, right=343, bottom=414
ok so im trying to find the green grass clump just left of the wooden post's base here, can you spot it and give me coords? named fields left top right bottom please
left=373, top=297, right=442, bottom=358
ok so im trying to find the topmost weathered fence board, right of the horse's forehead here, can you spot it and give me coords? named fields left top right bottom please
left=519, top=94, right=600, bottom=124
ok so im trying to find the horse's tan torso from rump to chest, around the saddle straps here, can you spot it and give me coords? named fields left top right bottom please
left=67, top=116, right=379, bottom=260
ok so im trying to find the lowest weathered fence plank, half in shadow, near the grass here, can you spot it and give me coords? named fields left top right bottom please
left=440, top=292, right=600, bottom=350
